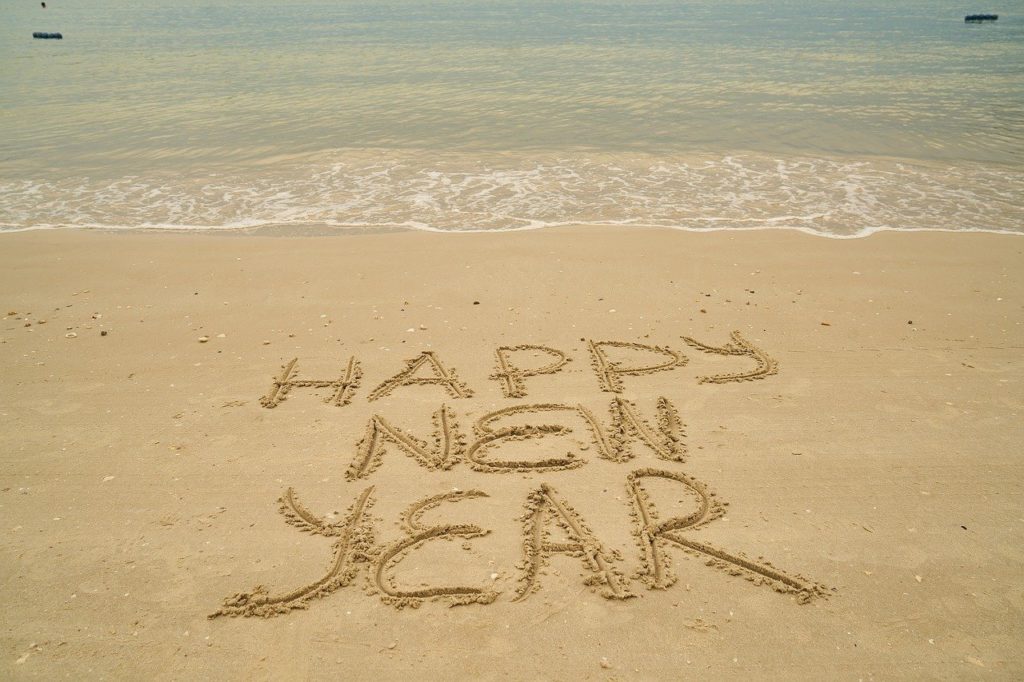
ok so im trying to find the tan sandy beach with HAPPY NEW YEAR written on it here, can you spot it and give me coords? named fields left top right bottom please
left=0, top=227, right=1024, bottom=680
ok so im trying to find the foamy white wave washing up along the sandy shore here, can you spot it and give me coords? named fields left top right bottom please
left=0, top=151, right=1024, bottom=238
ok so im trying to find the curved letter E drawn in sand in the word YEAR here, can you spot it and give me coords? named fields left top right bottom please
left=370, top=491, right=498, bottom=608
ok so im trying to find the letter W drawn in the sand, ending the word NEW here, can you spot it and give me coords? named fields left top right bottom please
left=578, top=395, right=686, bottom=462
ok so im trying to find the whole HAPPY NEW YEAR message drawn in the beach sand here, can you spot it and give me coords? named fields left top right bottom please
left=211, top=332, right=826, bottom=617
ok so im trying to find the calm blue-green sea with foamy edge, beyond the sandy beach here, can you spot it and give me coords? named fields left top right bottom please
left=0, top=0, right=1024, bottom=237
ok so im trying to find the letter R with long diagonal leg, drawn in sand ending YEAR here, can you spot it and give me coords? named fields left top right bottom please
left=626, top=469, right=826, bottom=603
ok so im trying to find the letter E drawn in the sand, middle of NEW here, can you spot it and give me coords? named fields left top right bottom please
left=466, top=403, right=586, bottom=473
